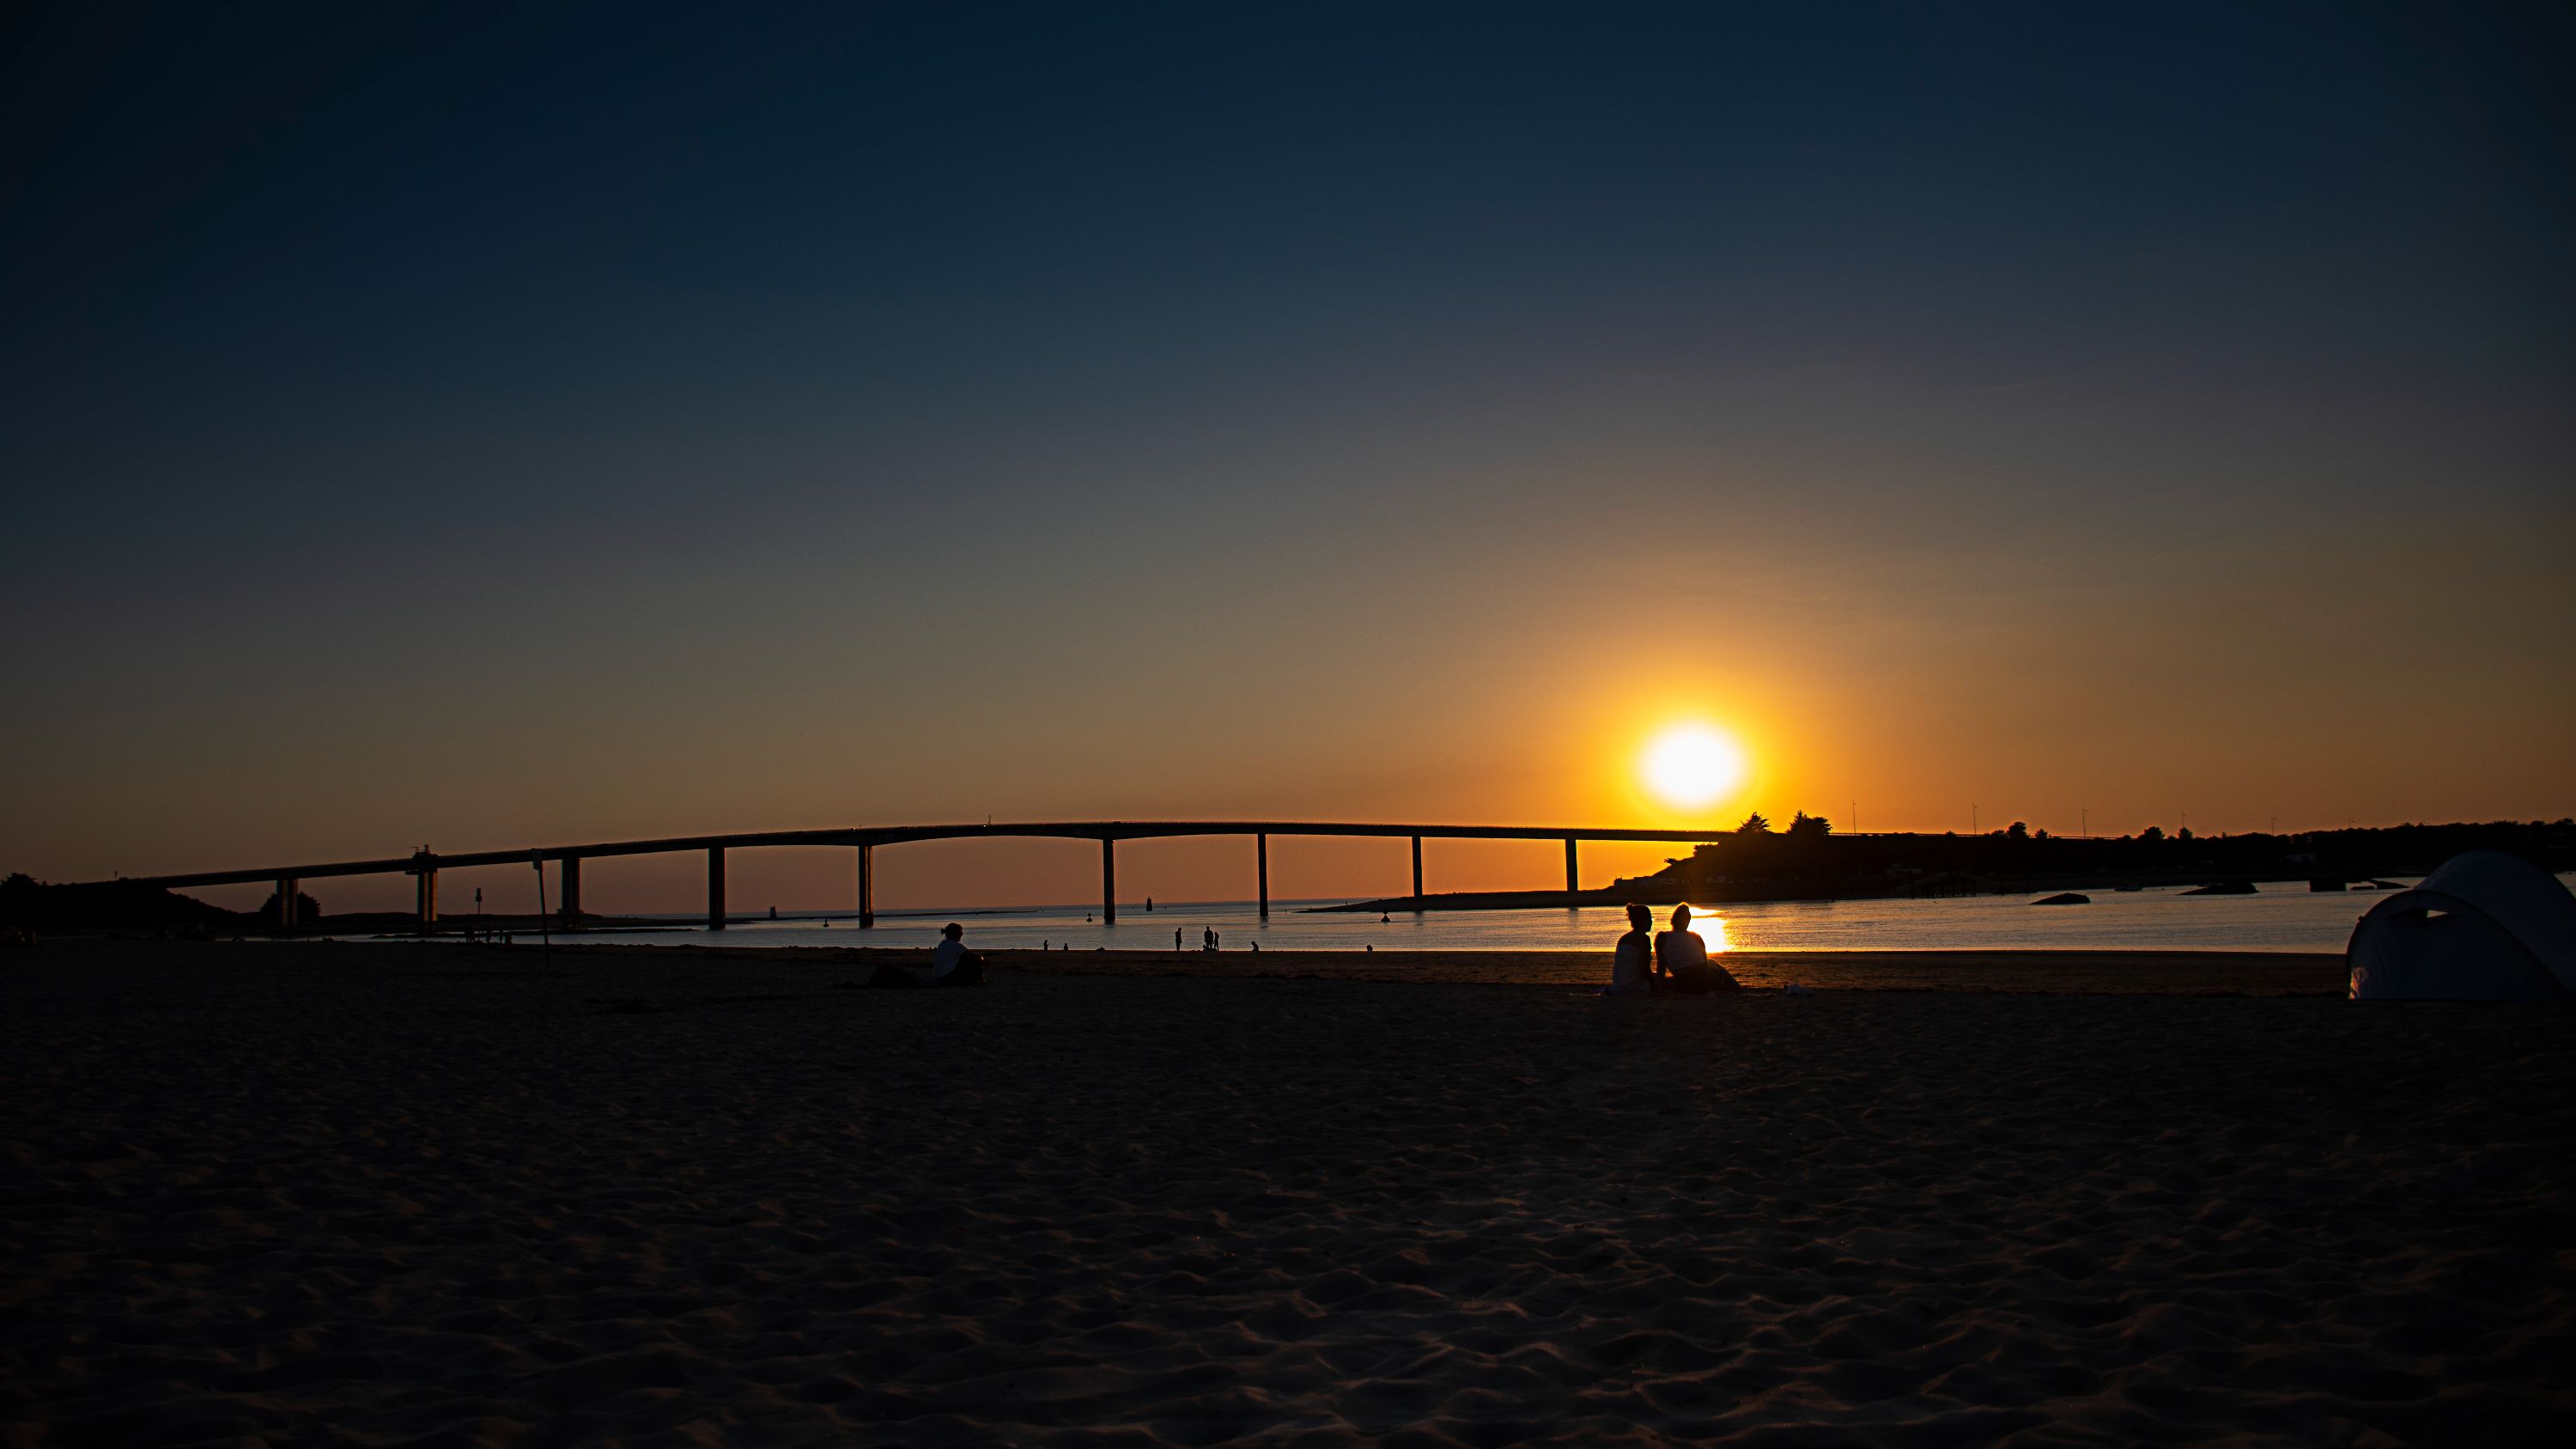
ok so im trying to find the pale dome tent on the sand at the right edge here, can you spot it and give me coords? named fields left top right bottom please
left=2344, top=851, right=2576, bottom=1003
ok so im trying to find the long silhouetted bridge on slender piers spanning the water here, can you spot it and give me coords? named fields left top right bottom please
left=137, top=820, right=1723, bottom=931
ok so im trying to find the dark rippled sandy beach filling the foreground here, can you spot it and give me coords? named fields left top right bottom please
left=0, top=941, right=2576, bottom=1446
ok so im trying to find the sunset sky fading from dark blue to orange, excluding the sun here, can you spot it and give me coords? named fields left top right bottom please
left=0, top=5, right=2576, bottom=910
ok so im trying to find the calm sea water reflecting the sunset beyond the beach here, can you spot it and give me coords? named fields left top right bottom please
left=479, top=877, right=2568, bottom=952
